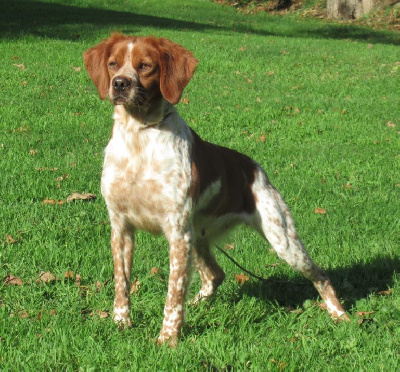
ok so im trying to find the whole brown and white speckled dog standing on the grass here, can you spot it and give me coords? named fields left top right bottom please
left=84, top=34, right=348, bottom=345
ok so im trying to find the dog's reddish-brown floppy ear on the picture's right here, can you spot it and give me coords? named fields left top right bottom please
left=159, top=38, right=198, bottom=105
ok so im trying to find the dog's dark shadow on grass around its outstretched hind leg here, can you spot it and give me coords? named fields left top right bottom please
left=234, top=256, right=400, bottom=309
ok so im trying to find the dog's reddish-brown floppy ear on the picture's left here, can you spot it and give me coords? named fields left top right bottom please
left=83, top=34, right=124, bottom=99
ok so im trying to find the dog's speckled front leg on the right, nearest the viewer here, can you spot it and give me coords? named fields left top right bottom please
left=158, top=228, right=192, bottom=347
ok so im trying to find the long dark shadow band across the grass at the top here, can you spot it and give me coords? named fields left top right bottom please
left=0, top=0, right=400, bottom=45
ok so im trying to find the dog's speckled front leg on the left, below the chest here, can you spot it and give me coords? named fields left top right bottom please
left=111, top=228, right=134, bottom=327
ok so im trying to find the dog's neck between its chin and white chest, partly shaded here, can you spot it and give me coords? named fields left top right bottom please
left=114, top=98, right=177, bottom=128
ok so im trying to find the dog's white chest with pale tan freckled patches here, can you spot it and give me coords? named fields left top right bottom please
left=101, top=107, right=192, bottom=233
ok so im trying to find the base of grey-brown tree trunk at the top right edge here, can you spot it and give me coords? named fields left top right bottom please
left=326, top=0, right=375, bottom=19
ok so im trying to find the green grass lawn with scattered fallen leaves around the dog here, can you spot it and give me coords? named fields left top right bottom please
left=0, top=0, right=400, bottom=371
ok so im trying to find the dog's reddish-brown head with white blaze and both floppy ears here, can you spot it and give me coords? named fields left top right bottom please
left=83, top=34, right=197, bottom=108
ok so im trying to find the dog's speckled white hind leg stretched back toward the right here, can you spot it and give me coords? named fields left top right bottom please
left=252, top=171, right=349, bottom=320
